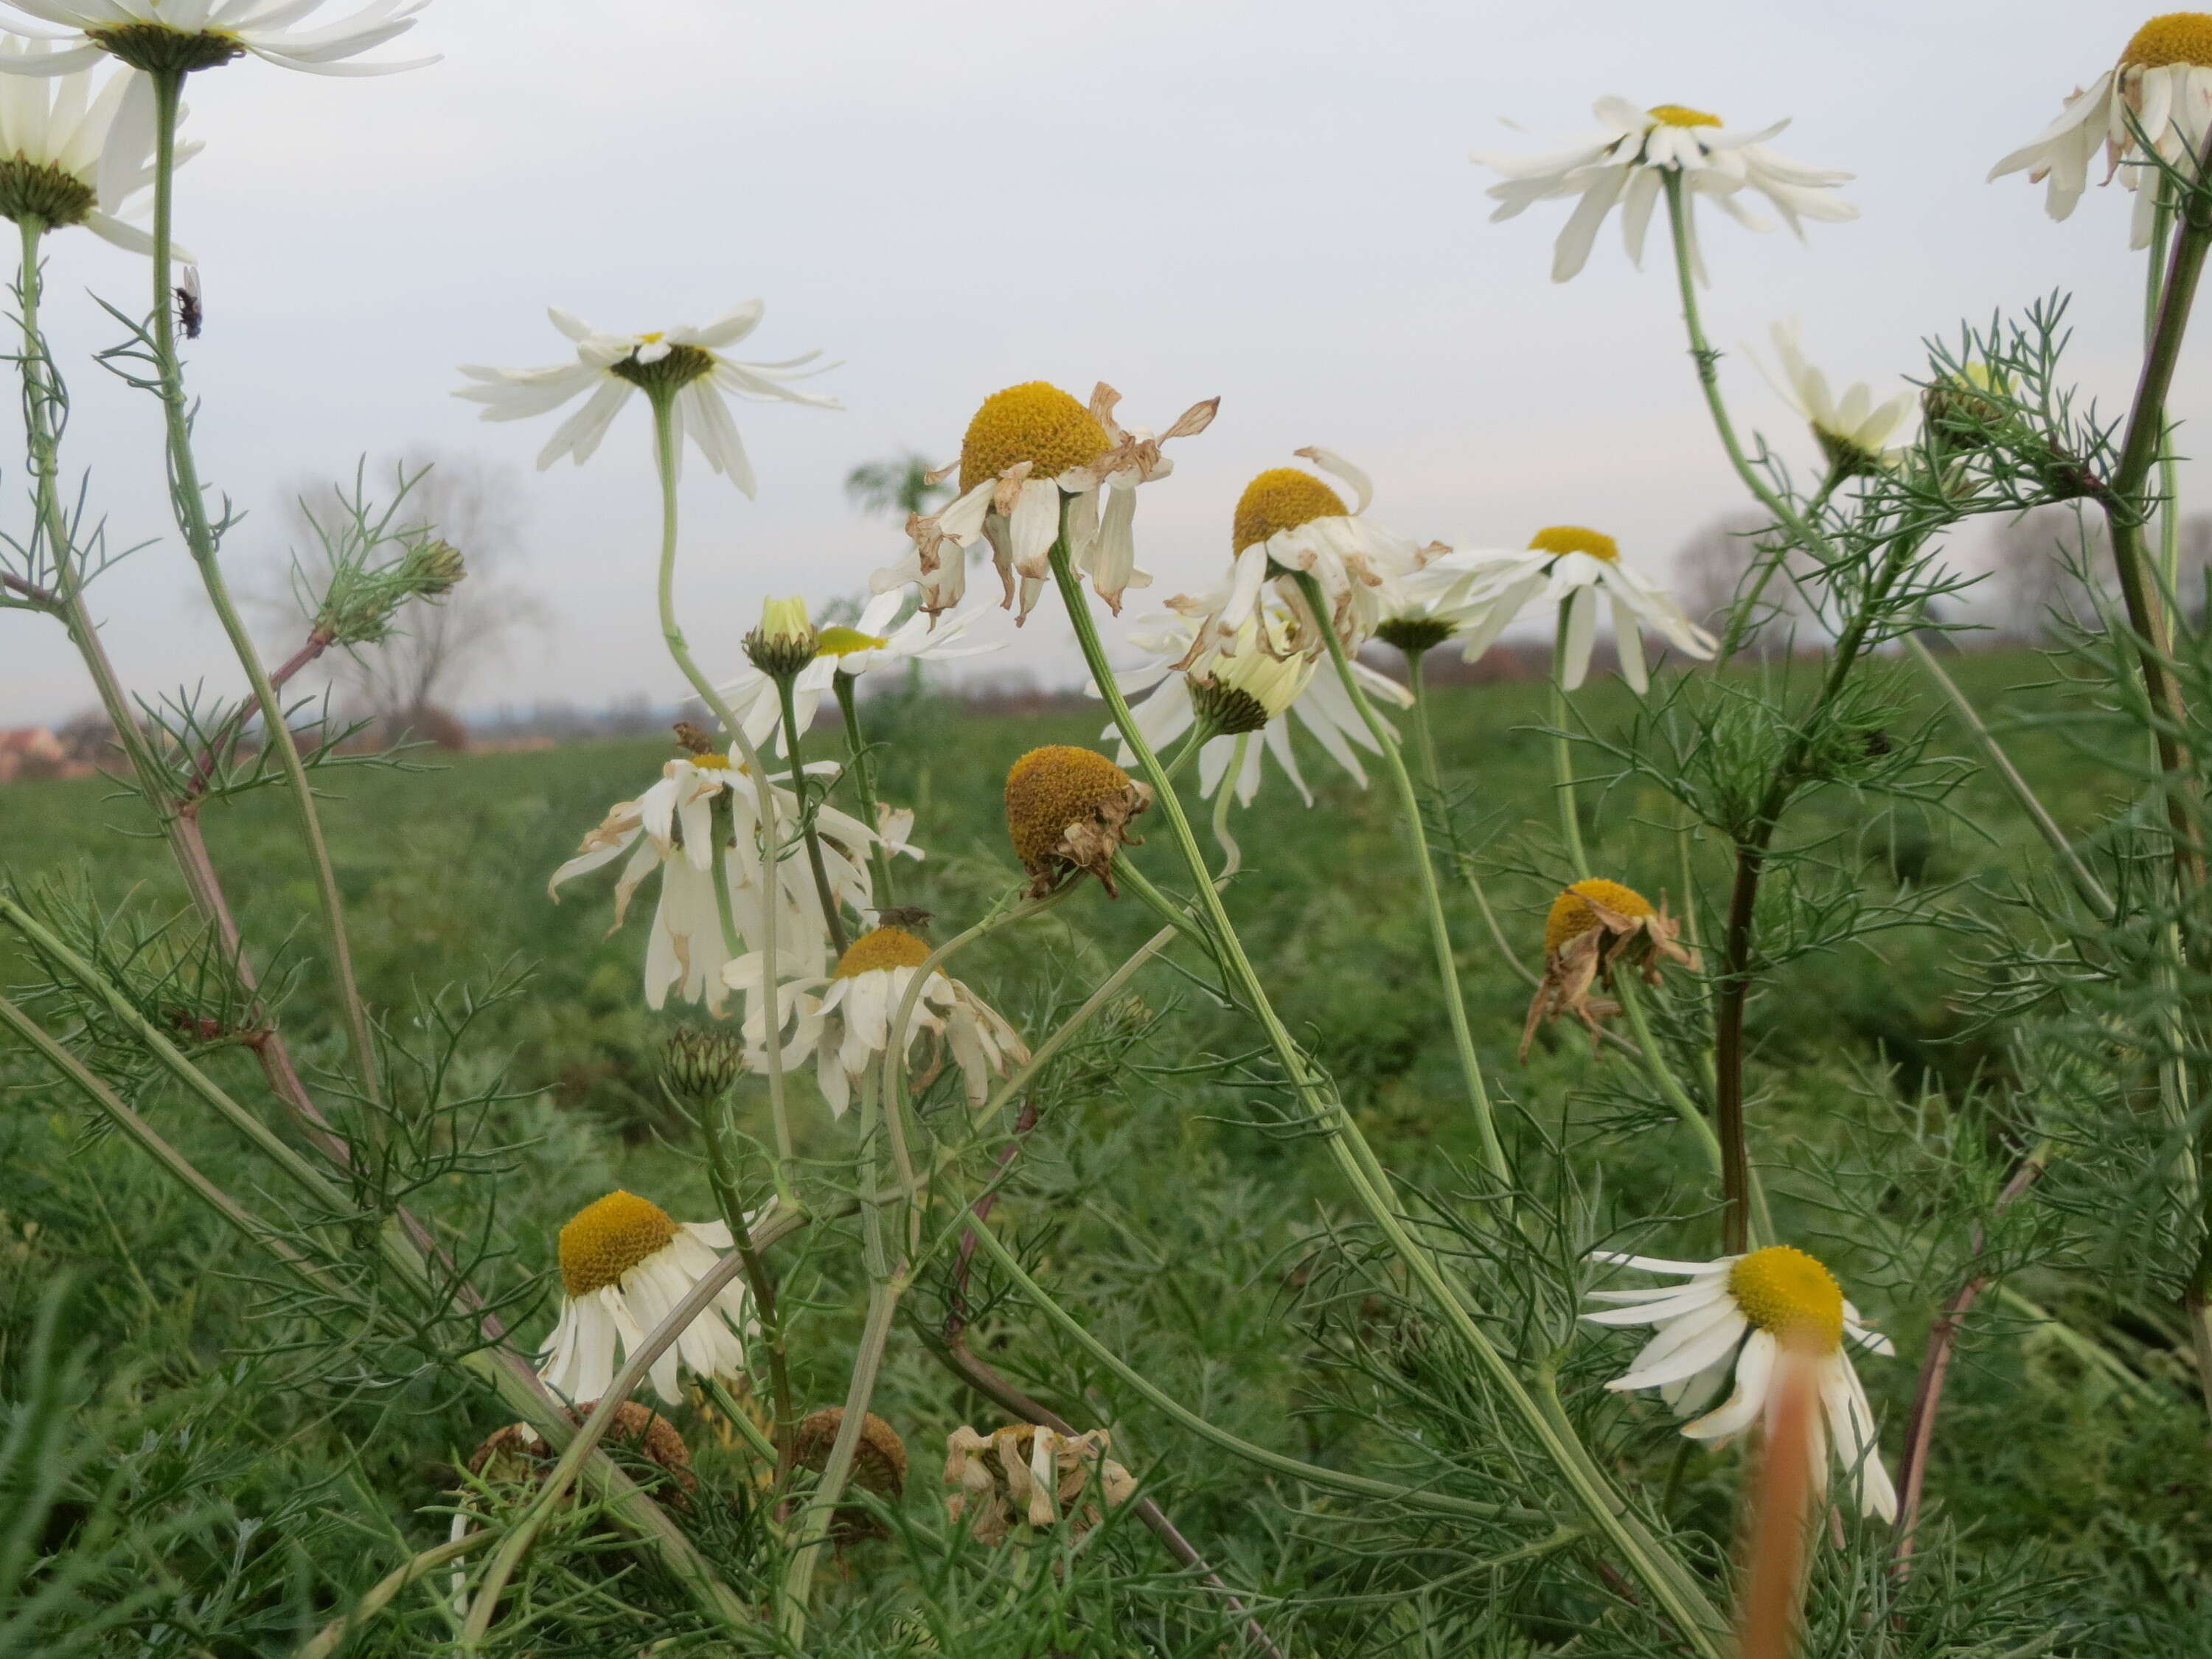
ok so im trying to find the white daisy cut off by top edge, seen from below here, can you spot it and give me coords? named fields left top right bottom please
left=0, top=0, right=438, bottom=75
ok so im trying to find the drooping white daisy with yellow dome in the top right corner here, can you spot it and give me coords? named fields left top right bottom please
left=1989, top=11, right=2212, bottom=248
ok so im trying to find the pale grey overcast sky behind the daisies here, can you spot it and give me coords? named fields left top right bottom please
left=0, top=0, right=2205, bottom=726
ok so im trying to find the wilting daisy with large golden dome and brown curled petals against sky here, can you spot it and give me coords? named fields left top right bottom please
left=872, top=380, right=1221, bottom=622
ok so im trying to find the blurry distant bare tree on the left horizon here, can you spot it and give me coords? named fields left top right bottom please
left=288, top=449, right=546, bottom=741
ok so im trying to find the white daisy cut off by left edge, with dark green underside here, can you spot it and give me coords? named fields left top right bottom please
left=0, top=40, right=184, bottom=261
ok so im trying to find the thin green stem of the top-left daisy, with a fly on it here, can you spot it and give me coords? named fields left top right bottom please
left=153, top=71, right=383, bottom=1102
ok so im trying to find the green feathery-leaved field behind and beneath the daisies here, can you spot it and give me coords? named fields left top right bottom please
left=0, top=655, right=2212, bottom=1659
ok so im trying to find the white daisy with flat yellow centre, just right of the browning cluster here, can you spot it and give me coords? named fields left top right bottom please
left=1429, top=524, right=1719, bottom=692
